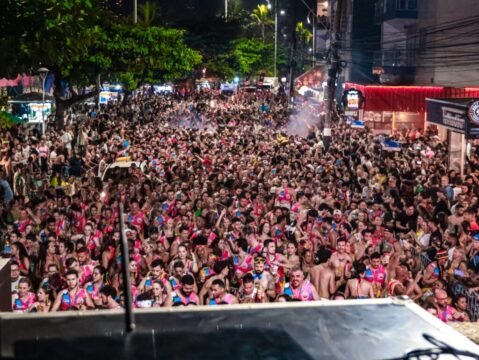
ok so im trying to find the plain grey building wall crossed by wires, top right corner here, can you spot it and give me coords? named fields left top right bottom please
left=411, top=0, right=479, bottom=88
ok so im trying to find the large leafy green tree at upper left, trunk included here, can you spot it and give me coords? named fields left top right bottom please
left=0, top=0, right=201, bottom=127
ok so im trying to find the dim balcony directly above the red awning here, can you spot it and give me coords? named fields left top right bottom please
left=373, top=49, right=416, bottom=85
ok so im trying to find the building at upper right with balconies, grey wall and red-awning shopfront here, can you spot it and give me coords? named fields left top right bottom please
left=343, top=0, right=479, bottom=132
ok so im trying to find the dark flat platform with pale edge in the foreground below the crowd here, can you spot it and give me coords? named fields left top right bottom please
left=0, top=299, right=479, bottom=360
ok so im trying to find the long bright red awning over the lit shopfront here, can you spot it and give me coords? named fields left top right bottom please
left=345, top=83, right=479, bottom=113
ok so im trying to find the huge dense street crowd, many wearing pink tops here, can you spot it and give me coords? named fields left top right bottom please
left=0, top=87, right=479, bottom=322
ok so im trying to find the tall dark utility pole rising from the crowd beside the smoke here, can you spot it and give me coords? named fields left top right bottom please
left=323, top=0, right=344, bottom=150
